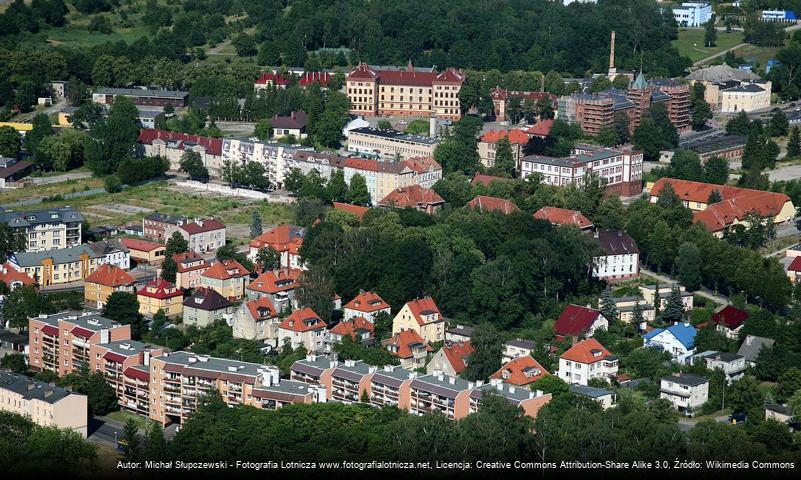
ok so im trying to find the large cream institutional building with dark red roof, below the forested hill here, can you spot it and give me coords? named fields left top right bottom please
left=345, top=62, right=465, bottom=120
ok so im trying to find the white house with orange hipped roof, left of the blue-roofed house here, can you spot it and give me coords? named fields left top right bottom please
left=558, top=338, right=619, bottom=385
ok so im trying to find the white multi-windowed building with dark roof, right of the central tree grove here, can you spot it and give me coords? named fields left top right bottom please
left=592, top=230, right=640, bottom=282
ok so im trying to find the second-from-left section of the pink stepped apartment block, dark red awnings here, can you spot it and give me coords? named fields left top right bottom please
left=89, top=340, right=165, bottom=415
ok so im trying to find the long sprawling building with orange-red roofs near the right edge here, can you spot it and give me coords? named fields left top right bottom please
left=649, top=178, right=795, bottom=237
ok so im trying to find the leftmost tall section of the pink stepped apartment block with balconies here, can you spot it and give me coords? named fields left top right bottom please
left=28, top=312, right=131, bottom=377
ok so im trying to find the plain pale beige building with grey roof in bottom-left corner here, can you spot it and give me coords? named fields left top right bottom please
left=0, top=371, right=89, bottom=438
